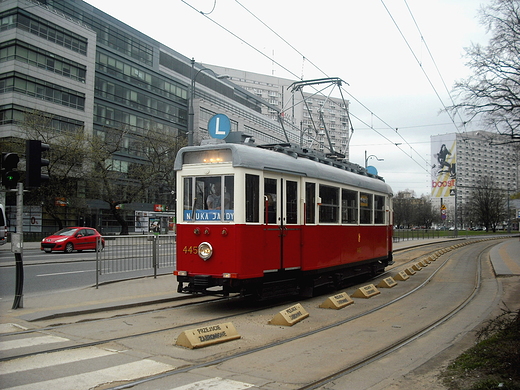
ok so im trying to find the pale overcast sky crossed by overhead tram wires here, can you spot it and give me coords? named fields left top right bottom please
left=87, top=0, right=489, bottom=196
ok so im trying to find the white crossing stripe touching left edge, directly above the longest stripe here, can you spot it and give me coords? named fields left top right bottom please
left=0, top=347, right=117, bottom=375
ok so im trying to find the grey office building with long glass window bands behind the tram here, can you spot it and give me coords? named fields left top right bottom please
left=0, top=0, right=290, bottom=229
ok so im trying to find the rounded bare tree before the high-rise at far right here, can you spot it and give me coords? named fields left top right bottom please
left=469, top=176, right=507, bottom=232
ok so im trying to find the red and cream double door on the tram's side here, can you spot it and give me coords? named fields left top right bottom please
left=264, top=176, right=301, bottom=269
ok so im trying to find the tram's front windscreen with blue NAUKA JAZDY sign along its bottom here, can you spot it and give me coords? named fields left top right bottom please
left=183, top=176, right=235, bottom=222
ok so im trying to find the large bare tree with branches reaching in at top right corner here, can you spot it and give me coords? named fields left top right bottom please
left=448, top=0, right=520, bottom=143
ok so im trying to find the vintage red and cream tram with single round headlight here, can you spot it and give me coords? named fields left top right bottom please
left=174, top=143, right=392, bottom=296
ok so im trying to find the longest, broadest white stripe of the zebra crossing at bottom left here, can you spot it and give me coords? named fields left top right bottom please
left=4, top=359, right=174, bottom=390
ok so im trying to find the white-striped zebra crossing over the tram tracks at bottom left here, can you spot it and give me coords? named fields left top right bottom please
left=0, top=324, right=253, bottom=390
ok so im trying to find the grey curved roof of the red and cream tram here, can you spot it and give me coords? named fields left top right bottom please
left=174, top=143, right=393, bottom=194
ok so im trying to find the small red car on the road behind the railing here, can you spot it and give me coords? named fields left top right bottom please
left=40, top=227, right=105, bottom=253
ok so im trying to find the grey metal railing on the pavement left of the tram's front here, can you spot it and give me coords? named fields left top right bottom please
left=96, top=235, right=175, bottom=287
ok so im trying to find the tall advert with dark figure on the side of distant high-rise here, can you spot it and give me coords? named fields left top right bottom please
left=431, top=133, right=457, bottom=198
